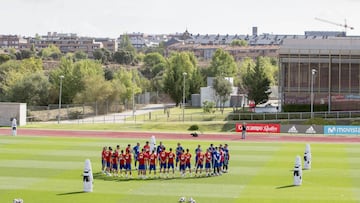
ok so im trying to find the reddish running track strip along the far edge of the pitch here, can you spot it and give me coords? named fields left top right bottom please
left=0, top=128, right=360, bottom=143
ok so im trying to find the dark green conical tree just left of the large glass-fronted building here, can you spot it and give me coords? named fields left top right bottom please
left=243, top=57, right=271, bottom=105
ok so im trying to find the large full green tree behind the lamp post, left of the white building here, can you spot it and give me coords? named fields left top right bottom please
left=163, top=52, right=196, bottom=106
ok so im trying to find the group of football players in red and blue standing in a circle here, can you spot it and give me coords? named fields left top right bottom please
left=101, top=141, right=230, bottom=179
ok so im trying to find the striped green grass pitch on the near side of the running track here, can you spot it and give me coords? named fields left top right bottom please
left=0, top=136, right=360, bottom=203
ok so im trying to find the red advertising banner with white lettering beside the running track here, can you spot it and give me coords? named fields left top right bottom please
left=235, top=123, right=280, bottom=133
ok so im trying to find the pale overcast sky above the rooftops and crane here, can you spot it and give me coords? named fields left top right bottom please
left=0, top=0, right=360, bottom=38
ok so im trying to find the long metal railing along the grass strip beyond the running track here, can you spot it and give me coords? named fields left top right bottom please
left=28, top=108, right=360, bottom=124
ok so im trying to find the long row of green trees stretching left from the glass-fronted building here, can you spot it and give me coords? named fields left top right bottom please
left=0, top=47, right=277, bottom=110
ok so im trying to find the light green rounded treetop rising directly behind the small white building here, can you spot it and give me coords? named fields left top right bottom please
left=208, top=49, right=237, bottom=77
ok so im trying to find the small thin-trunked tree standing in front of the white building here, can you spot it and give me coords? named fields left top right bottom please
left=213, top=76, right=232, bottom=113
